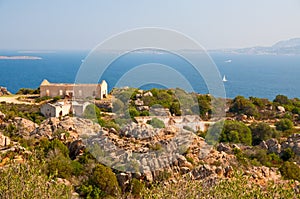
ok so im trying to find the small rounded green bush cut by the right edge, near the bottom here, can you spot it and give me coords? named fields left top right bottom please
left=279, top=162, right=300, bottom=181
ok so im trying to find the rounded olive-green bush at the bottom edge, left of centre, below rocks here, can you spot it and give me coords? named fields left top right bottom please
left=89, top=164, right=120, bottom=196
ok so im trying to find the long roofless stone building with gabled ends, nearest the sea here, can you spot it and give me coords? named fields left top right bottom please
left=40, top=79, right=107, bottom=99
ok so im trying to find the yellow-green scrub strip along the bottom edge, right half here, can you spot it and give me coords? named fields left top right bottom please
left=142, top=173, right=299, bottom=199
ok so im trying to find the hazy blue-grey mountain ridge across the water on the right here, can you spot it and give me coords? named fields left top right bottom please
left=211, top=38, right=300, bottom=55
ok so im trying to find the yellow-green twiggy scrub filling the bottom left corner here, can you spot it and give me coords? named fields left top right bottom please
left=0, top=157, right=71, bottom=198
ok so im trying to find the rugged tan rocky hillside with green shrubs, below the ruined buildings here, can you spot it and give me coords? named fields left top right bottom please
left=0, top=108, right=300, bottom=198
